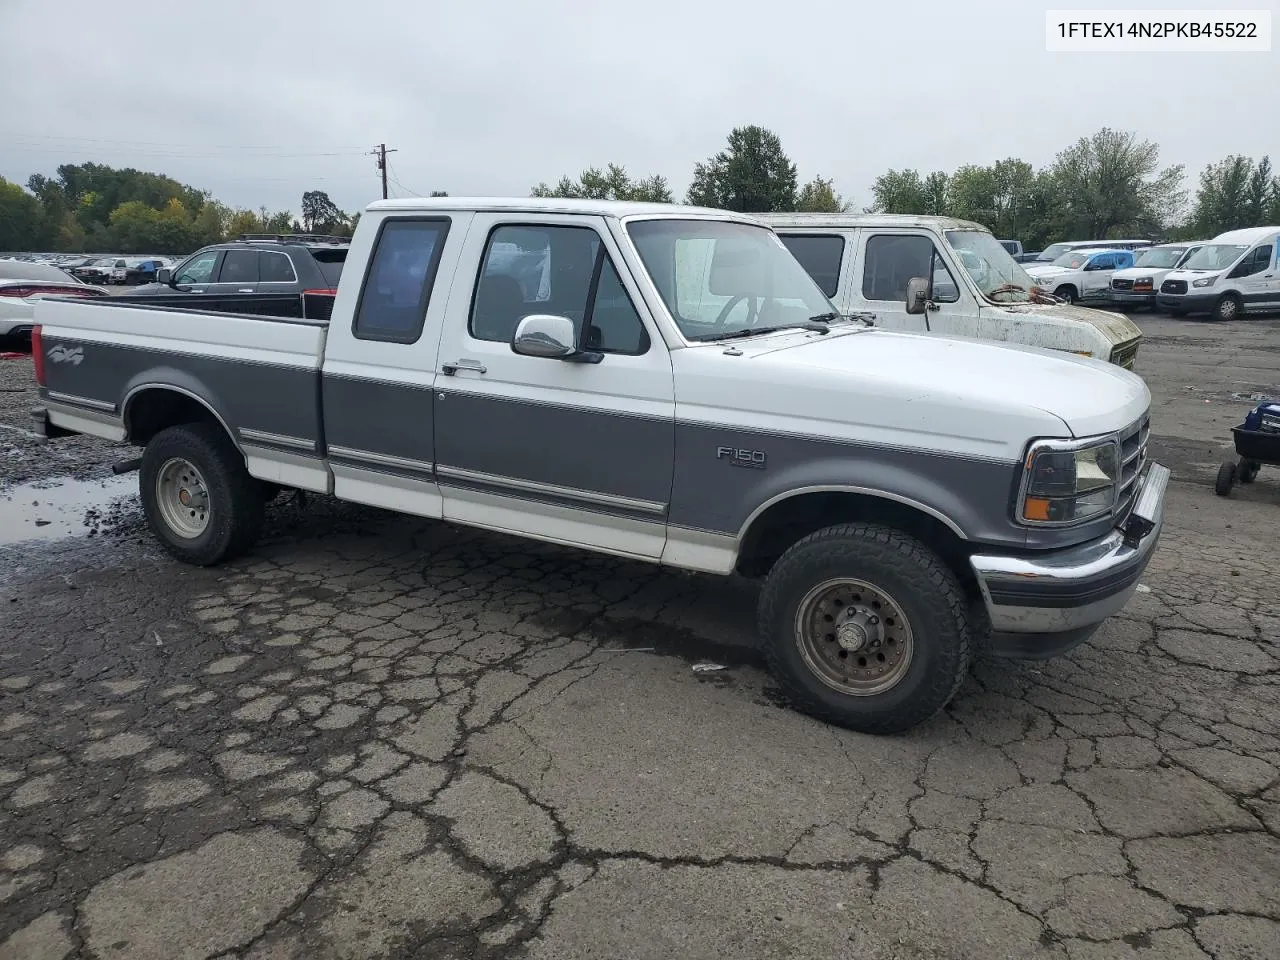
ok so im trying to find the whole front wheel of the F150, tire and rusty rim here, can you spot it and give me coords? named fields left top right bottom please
left=759, top=524, right=973, bottom=733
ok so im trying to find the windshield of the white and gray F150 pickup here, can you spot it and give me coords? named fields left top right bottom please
left=627, top=220, right=837, bottom=340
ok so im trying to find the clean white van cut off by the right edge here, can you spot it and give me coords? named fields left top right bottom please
left=1156, top=227, right=1280, bottom=320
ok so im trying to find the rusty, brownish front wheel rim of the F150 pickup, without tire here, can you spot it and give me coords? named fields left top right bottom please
left=795, top=577, right=915, bottom=696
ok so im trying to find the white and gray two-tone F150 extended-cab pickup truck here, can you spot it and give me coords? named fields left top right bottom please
left=33, top=197, right=1169, bottom=733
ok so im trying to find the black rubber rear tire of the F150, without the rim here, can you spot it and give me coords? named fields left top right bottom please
left=138, top=424, right=264, bottom=567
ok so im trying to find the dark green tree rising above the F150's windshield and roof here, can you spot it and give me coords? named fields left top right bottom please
left=686, top=125, right=796, bottom=214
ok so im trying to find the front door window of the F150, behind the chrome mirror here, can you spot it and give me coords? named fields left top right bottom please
left=468, top=225, right=649, bottom=355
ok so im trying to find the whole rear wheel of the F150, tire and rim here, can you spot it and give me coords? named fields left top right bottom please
left=138, top=424, right=264, bottom=567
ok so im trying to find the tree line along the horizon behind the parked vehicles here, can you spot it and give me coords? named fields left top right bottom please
left=0, top=125, right=1280, bottom=253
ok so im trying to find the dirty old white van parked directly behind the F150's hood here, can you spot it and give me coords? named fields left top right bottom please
left=751, top=214, right=1142, bottom=370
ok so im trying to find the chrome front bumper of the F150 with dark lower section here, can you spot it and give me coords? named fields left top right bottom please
left=969, top=463, right=1169, bottom=659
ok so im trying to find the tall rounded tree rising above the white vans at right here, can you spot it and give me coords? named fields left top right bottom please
left=1051, top=127, right=1187, bottom=238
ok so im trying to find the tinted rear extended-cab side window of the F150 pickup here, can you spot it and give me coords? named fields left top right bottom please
left=352, top=219, right=449, bottom=343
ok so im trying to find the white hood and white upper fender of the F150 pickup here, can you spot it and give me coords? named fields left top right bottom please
left=676, top=330, right=1151, bottom=461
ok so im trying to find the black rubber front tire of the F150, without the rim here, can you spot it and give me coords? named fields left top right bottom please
left=759, top=524, right=973, bottom=733
